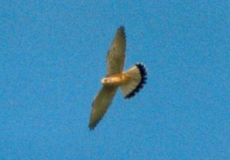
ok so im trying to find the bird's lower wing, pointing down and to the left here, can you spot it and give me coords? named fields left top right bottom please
left=89, top=86, right=117, bottom=129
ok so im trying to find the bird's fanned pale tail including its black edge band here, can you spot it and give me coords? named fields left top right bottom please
left=120, top=63, right=147, bottom=98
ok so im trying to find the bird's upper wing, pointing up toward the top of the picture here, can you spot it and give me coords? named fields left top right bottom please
left=107, top=26, right=126, bottom=76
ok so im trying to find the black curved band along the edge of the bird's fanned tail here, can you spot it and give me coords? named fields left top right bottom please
left=125, top=63, right=147, bottom=98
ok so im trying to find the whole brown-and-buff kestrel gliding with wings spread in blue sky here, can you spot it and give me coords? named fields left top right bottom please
left=89, top=26, right=147, bottom=130
